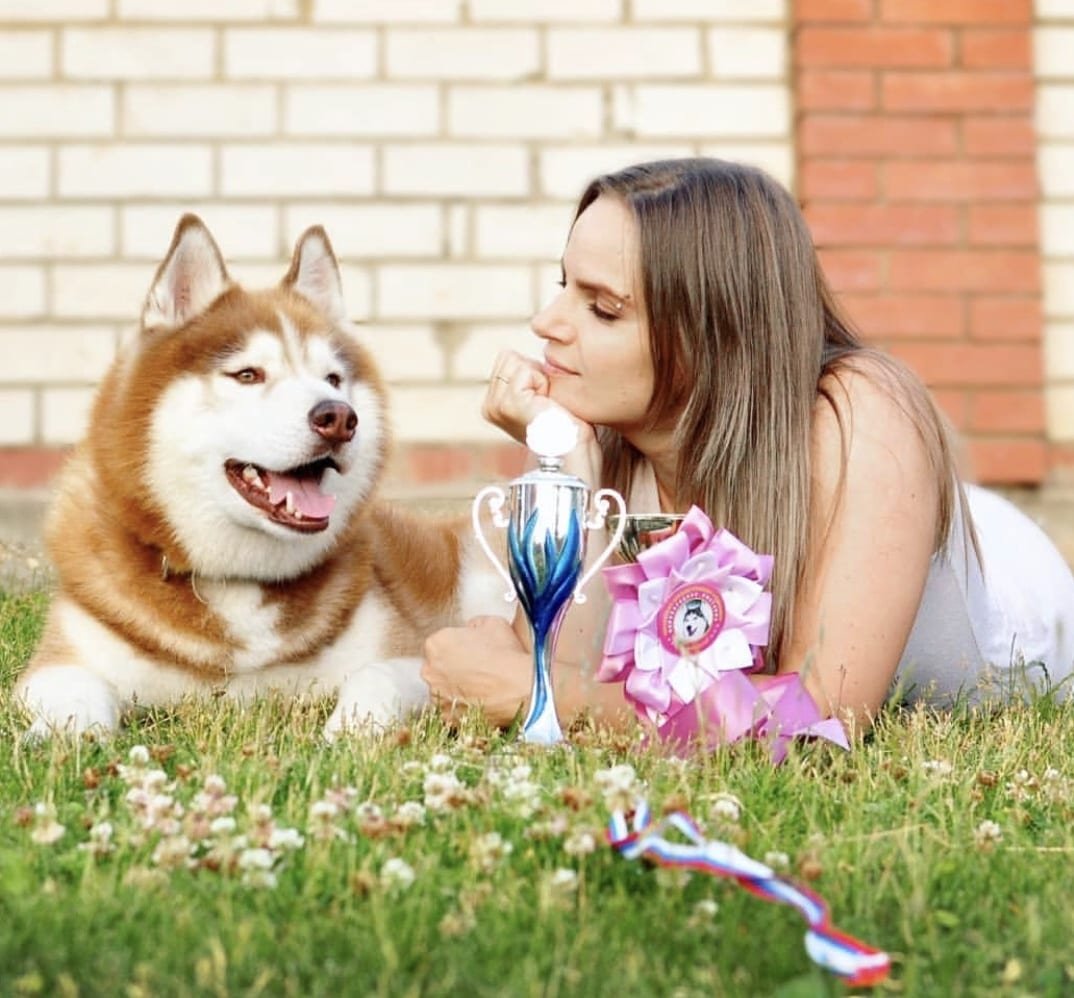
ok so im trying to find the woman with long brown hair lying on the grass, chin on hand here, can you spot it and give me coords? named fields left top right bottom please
left=423, top=159, right=1074, bottom=723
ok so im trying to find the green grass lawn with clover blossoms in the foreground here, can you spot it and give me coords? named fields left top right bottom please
left=0, top=591, right=1074, bottom=998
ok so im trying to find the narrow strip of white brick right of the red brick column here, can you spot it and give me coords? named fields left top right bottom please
left=1033, top=0, right=1074, bottom=440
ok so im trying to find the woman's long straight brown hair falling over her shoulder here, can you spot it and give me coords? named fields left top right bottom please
left=575, top=159, right=969, bottom=668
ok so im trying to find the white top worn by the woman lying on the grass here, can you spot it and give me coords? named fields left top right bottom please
left=629, top=463, right=1074, bottom=707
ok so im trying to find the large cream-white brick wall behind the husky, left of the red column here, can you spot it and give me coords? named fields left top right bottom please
left=0, top=0, right=794, bottom=446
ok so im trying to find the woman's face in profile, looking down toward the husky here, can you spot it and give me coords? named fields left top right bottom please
left=532, top=196, right=653, bottom=434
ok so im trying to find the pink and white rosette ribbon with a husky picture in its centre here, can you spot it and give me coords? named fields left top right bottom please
left=597, top=506, right=848, bottom=763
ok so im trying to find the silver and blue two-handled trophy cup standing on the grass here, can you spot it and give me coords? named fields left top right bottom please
left=473, top=408, right=626, bottom=744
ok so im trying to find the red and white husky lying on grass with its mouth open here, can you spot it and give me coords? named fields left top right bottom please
left=16, top=215, right=506, bottom=736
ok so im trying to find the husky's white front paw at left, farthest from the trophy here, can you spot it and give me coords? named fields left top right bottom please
left=16, top=665, right=119, bottom=740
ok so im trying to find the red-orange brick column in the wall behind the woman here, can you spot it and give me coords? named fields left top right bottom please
left=793, top=0, right=1048, bottom=483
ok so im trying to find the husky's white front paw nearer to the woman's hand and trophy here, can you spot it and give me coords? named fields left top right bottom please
left=324, top=659, right=429, bottom=741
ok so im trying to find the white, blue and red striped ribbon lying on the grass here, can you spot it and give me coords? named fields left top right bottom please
left=608, top=800, right=891, bottom=987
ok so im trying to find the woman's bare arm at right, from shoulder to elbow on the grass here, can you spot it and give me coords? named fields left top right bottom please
left=778, top=370, right=939, bottom=725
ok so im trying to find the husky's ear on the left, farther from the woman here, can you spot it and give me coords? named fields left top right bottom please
left=142, top=215, right=231, bottom=329
